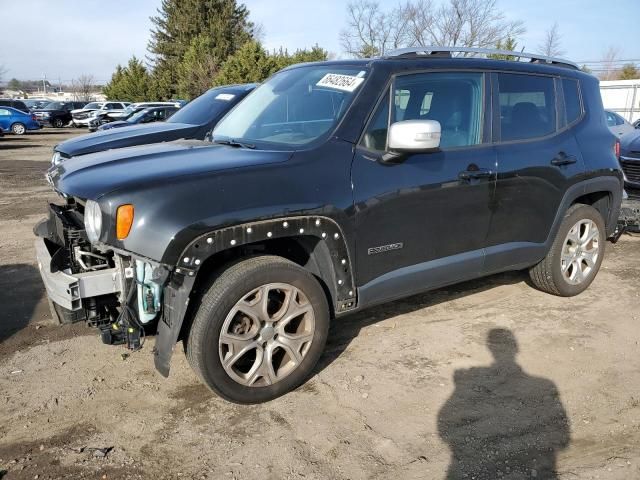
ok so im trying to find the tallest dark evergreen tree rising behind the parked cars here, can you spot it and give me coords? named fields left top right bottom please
left=148, top=0, right=253, bottom=98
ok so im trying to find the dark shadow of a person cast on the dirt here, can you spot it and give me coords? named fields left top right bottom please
left=438, top=328, right=570, bottom=480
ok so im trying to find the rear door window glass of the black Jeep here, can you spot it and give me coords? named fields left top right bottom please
left=498, top=73, right=556, bottom=141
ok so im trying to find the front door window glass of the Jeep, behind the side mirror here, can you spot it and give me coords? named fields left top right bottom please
left=391, top=72, right=484, bottom=148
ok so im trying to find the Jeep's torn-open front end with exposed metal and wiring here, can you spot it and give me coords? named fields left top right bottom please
left=34, top=197, right=169, bottom=350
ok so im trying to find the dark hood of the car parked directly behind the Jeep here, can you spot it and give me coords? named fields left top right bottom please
left=54, top=122, right=199, bottom=157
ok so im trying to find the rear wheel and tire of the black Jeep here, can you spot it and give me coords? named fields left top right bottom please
left=529, top=204, right=606, bottom=297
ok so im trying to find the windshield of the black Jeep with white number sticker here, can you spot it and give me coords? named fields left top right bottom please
left=213, top=65, right=367, bottom=146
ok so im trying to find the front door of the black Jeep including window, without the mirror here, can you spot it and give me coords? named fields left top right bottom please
left=352, top=72, right=496, bottom=305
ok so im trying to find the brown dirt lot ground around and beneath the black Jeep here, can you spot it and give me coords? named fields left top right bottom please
left=0, top=130, right=640, bottom=479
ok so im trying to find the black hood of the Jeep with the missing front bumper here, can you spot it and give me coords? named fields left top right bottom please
left=47, top=140, right=292, bottom=200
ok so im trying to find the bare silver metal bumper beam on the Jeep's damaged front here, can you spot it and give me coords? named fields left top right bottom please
left=35, top=224, right=123, bottom=311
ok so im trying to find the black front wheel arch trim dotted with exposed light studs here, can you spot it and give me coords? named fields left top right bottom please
left=154, top=215, right=356, bottom=377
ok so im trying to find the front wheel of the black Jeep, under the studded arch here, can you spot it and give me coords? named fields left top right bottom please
left=186, top=256, right=329, bottom=404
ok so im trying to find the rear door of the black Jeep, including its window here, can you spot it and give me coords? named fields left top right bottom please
left=485, top=73, right=584, bottom=273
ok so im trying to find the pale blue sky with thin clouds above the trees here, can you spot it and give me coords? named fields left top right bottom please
left=0, top=0, right=640, bottom=83
